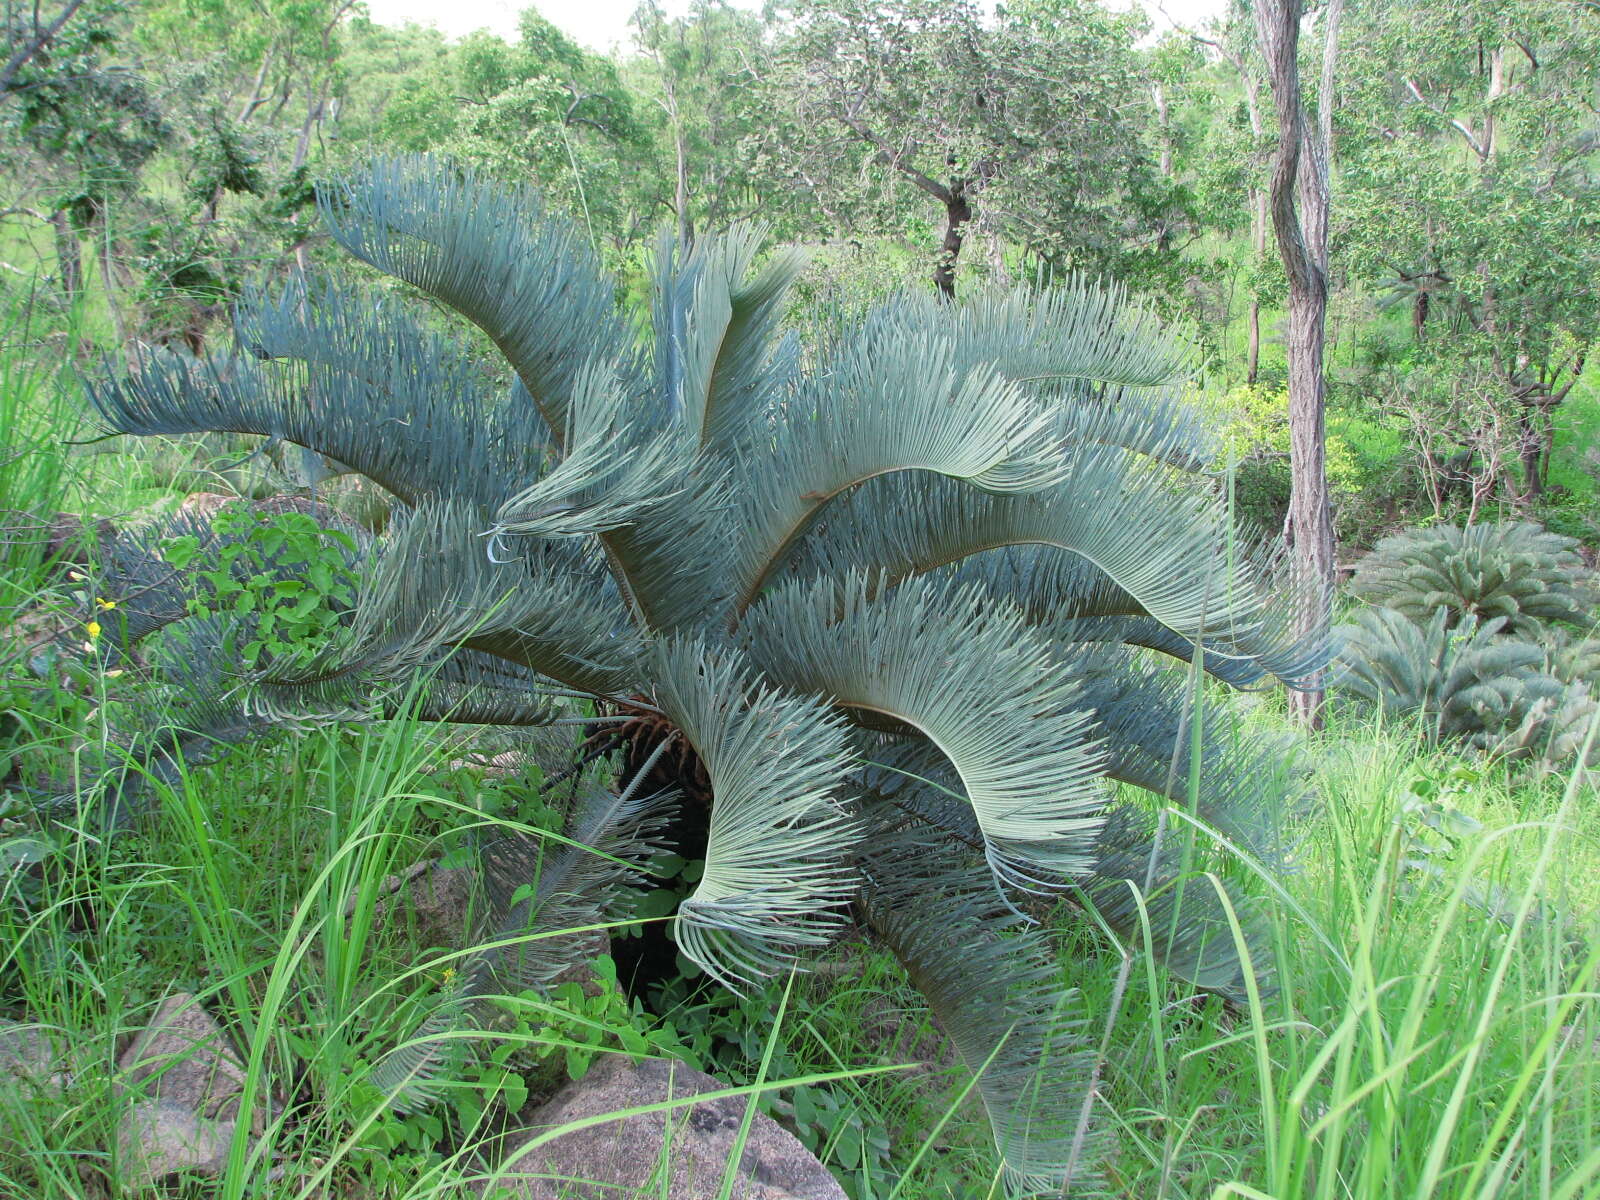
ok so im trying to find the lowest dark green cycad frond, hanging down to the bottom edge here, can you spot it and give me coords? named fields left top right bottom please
left=861, top=832, right=1098, bottom=1197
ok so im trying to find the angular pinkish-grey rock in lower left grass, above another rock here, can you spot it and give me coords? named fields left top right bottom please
left=117, top=992, right=245, bottom=1120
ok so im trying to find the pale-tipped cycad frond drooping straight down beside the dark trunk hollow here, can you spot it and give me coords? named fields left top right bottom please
left=654, top=638, right=859, bottom=982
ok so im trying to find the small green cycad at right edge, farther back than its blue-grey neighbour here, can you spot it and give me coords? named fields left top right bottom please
left=1352, top=522, right=1597, bottom=637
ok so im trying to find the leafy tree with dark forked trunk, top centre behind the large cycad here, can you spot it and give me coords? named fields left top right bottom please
left=748, top=0, right=1171, bottom=291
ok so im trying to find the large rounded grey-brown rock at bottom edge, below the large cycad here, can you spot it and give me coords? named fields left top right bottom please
left=480, top=1054, right=845, bottom=1200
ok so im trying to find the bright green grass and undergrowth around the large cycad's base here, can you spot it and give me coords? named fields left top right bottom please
left=0, top=643, right=1600, bottom=1200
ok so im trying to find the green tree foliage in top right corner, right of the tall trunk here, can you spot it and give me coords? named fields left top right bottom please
left=1336, top=0, right=1600, bottom=498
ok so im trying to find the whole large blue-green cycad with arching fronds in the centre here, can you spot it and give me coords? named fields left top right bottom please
left=78, top=160, right=1323, bottom=1192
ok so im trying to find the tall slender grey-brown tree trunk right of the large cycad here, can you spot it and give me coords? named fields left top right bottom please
left=1254, top=0, right=1344, bottom=728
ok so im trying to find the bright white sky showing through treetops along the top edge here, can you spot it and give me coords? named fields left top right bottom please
left=368, top=0, right=1224, bottom=50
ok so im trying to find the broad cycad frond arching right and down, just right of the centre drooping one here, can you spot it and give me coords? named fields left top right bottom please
left=742, top=574, right=1104, bottom=888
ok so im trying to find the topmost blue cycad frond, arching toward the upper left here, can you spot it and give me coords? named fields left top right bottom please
left=318, top=157, right=632, bottom=432
